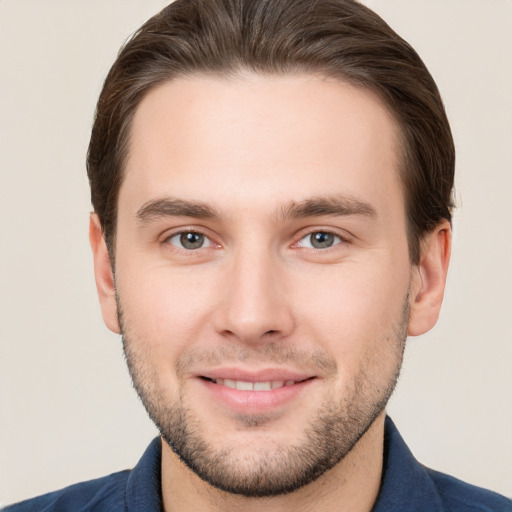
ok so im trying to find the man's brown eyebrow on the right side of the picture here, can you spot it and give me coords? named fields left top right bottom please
left=281, top=195, right=377, bottom=219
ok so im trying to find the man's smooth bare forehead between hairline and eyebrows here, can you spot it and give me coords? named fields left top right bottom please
left=120, top=74, right=402, bottom=216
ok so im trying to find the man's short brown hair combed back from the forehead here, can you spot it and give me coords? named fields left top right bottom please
left=87, top=0, right=455, bottom=263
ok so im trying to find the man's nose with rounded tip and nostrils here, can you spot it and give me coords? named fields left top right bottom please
left=213, top=247, right=295, bottom=344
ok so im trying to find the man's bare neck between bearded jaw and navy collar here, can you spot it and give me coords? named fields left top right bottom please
left=162, top=412, right=385, bottom=512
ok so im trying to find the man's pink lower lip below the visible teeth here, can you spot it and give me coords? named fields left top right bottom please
left=198, top=378, right=316, bottom=414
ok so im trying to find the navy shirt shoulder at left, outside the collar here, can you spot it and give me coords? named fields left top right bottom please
left=2, top=470, right=130, bottom=512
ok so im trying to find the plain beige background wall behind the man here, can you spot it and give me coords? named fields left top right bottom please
left=0, top=0, right=512, bottom=504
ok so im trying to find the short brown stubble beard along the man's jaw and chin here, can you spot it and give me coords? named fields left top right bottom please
left=117, top=297, right=410, bottom=498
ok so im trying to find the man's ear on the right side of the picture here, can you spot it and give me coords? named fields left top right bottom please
left=408, top=221, right=452, bottom=336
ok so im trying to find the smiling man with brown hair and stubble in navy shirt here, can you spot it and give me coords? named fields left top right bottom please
left=8, top=0, right=512, bottom=511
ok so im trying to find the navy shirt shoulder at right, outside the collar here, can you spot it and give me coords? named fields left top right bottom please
left=426, top=468, right=512, bottom=512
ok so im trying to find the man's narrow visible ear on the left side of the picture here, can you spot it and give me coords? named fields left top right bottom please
left=89, top=213, right=121, bottom=334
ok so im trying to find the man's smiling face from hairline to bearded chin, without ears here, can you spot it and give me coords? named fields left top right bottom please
left=99, top=75, right=416, bottom=496
